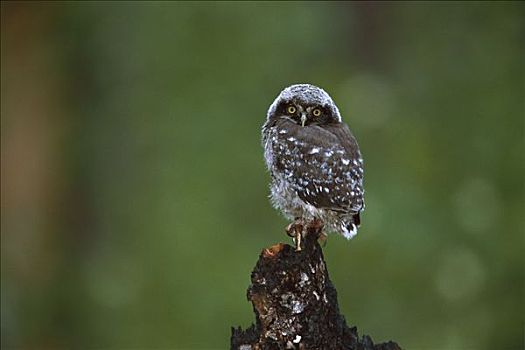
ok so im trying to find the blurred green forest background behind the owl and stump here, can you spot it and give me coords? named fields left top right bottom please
left=1, top=2, right=525, bottom=349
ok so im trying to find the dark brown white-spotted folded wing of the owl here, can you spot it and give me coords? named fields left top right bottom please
left=276, top=119, right=363, bottom=213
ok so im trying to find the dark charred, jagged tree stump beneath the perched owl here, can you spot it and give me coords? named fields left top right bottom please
left=231, top=224, right=401, bottom=350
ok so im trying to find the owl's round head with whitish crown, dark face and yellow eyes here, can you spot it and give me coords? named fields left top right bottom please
left=267, top=84, right=341, bottom=126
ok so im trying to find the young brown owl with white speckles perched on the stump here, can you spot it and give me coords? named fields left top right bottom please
left=262, top=84, right=364, bottom=250
